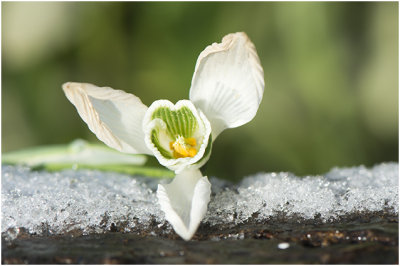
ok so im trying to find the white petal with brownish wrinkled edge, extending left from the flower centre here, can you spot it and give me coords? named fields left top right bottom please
left=63, top=82, right=152, bottom=154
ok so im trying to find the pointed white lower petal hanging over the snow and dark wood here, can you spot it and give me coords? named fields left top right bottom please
left=157, top=170, right=211, bottom=240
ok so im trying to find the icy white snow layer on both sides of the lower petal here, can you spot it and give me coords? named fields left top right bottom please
left=1, top=163, right=399, bottom=237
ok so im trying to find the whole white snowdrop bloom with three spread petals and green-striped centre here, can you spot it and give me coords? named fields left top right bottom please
left=63, top=32, right=264, bottom=240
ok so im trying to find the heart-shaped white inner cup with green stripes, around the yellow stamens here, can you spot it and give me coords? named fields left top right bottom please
left=143, top=100, right=212, bottom=173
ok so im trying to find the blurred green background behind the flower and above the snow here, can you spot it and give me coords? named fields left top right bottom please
left=2, top=2, right=398, bottom=180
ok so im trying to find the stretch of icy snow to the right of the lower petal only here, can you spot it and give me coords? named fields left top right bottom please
left=205, top=163, right=399, bottom=225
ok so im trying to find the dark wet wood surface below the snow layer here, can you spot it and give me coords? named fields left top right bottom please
left=2, top=213, right=398, bottom=264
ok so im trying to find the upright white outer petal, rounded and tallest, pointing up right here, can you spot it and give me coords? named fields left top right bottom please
left=189, top=32, right=264, bottom=139
